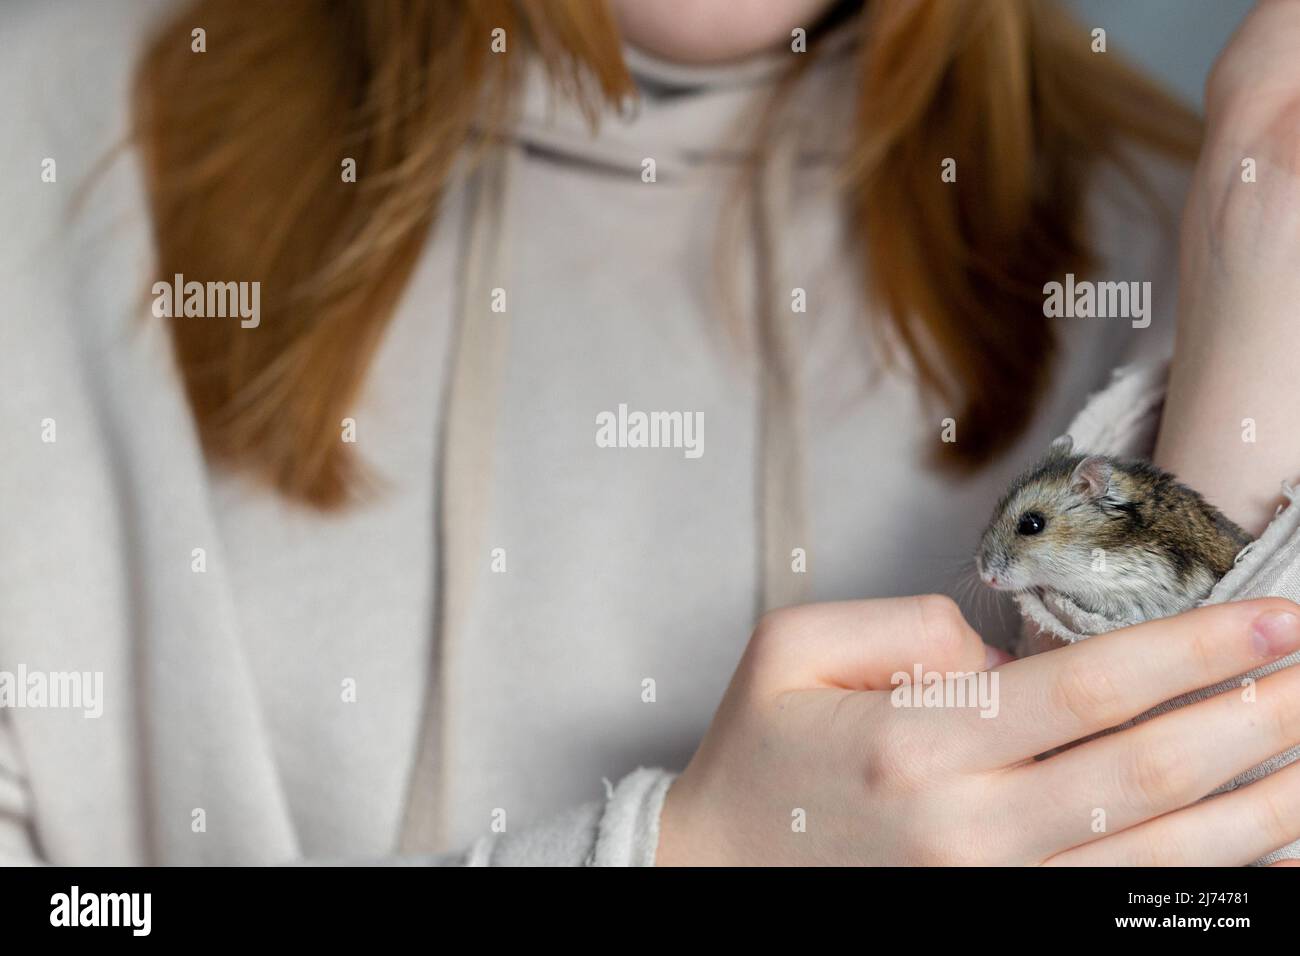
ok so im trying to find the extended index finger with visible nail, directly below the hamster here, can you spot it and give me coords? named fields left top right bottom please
left=931, top=598, right=1300, bottom=770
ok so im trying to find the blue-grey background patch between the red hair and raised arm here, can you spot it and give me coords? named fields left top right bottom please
left=1060, top=0, right=1253, bottom=107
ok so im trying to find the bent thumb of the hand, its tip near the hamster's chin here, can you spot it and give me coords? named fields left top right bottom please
left=748, top=594, right=997, bottom=691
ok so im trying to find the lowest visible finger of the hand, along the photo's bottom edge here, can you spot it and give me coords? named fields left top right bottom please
left=1048, top=763, right=1300, bottom=866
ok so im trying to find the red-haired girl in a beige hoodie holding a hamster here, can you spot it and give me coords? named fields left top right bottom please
left=0, top=0, right=1300, bottom=864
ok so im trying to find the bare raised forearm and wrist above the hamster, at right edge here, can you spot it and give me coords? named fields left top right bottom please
left=1156, top=0, right=1300, bottom=533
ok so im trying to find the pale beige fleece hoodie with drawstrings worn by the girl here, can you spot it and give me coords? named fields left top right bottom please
left=0, top=0, right=1206, bottom=864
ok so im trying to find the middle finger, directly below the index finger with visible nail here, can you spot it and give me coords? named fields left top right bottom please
left=1002, top=658, right=1300, bottom=857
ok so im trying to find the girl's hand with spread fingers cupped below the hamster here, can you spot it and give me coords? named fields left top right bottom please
left=657, top=596, right=1300, bottom=865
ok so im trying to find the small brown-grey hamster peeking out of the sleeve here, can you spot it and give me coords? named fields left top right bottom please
left=975, top=436, right=1252, bottom=623
